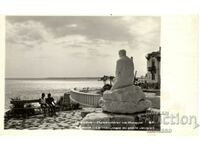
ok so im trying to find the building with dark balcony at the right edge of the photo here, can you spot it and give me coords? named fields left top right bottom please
left=146, top=47, right=161, bottom=87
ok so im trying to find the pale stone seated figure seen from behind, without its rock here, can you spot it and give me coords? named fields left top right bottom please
left=111, top=49, right=134, bottom=90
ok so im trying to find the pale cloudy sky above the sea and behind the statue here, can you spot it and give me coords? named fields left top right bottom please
left=6, top=16, right=161, bottom=78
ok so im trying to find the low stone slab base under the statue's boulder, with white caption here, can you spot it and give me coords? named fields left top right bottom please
left=81, top=111, right=160, bottom=131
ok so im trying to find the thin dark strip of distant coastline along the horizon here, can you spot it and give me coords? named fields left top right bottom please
left=5, top=77, right=101, bottom=80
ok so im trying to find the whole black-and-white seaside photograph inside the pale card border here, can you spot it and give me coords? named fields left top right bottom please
left=4, top=15, right=162, bottom=131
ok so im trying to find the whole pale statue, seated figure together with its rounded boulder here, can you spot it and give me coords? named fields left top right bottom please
left=100, top=50, right=151, bottom=113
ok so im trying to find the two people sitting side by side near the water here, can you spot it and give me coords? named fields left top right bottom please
left=40, top=93, right=56, bottom=116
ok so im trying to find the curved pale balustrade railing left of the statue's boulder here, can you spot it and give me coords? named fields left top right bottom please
left=70, top=90, right=101, bottom=107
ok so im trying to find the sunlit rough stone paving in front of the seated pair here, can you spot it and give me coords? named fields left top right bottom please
left=4, top=110, right=82, bottom=130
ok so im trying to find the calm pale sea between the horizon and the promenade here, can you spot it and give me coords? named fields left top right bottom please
left=5, top=79, right=103, bottom=109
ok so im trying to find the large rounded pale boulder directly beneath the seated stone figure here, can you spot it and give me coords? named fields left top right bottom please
left=100, top=86, right=151, bottom=114
